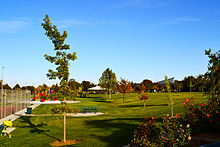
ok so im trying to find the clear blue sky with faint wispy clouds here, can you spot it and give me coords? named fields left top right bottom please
left=0, top=0, right=220, bottom=86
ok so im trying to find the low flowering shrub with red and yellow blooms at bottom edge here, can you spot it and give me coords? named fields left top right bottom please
left=130, top=114, right=191, bottom=147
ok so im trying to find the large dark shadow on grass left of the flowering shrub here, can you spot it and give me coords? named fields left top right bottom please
left=85, top=118, right=144, bottom=147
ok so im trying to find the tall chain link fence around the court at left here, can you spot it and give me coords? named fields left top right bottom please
left=0, top=89, right=31, bottom=119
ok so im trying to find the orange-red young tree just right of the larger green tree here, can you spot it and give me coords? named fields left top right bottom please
left=117, top=78, right=133, bottom=103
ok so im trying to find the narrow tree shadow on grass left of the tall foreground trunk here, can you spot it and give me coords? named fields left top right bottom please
left=15, top=116, right=61, bottom=141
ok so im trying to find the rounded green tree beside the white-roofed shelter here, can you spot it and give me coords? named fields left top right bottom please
left=99, top=68, right=117, bottom=99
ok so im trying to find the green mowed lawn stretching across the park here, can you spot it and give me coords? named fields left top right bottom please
left=0, top=92, right=206, bottom=147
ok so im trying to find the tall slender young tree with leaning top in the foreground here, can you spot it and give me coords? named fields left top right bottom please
left=41, top=15, right=77, bottom=142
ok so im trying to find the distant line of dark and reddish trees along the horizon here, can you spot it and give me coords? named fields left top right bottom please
left=0, top=74, right=209, bottom=93
